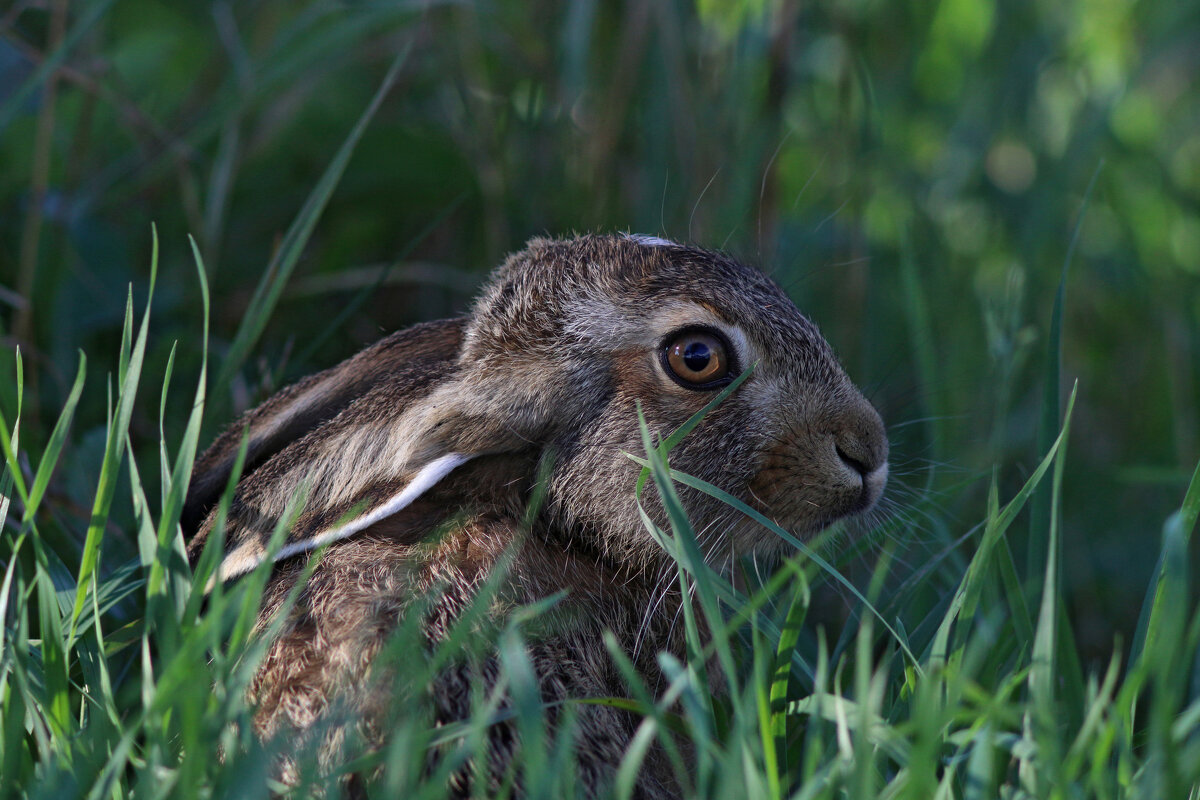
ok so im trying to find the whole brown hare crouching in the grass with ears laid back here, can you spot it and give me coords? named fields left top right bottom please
left=185, top=235, right=888, bottom=798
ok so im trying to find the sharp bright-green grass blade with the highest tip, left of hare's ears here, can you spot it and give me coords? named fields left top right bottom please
left=71, top=228, right=158, bottom=634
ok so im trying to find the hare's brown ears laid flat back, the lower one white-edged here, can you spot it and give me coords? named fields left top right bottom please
left=188, top=323, right=557, bottom=579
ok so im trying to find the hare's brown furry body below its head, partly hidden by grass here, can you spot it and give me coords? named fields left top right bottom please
left=251, top=513, right=682, bottom=798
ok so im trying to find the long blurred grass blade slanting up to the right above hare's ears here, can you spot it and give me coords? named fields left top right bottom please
left=214, top=43, right=412, bottom=398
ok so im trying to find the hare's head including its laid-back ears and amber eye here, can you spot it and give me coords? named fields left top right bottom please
left=184, top=236, right=888, bottom=577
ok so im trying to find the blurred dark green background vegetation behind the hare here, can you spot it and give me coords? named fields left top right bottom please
left=0, top=0, right=1200, bottom=658
